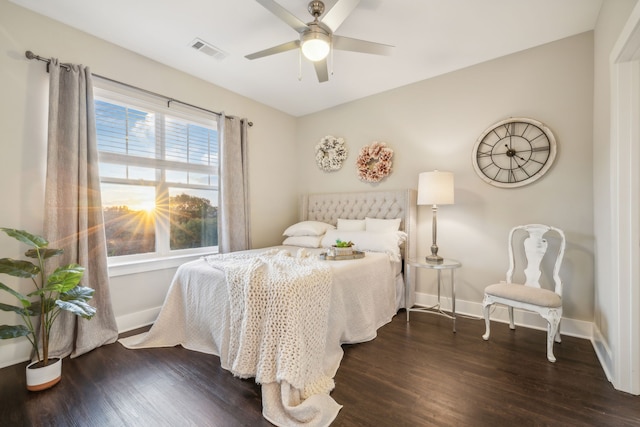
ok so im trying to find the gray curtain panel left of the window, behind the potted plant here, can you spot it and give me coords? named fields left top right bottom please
left=44, top=59, right=118, bottom=357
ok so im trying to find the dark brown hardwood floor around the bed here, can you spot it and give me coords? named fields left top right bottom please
left=0, top=312, right=640, bottom=427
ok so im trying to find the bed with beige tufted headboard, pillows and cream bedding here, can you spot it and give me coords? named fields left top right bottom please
left=120, top=190, right=416, bottom=426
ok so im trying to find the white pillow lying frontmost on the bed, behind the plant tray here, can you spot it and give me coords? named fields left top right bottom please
left=322, top=230, right=407, bottom=261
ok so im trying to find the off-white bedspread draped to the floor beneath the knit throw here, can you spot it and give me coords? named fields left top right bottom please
left=120, top=247, right=396, bottom=426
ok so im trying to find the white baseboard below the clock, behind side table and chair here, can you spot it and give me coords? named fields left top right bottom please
left=415, top=292, right=593, bottom=340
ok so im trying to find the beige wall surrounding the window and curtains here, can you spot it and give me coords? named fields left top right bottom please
left=0, top=0, right=297, bottom=366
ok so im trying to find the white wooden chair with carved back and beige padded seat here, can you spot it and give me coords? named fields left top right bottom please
left=482, top=224, right=565, bottom=362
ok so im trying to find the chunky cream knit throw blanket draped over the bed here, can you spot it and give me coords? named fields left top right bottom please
left=207, top=250, right=334, bottom=399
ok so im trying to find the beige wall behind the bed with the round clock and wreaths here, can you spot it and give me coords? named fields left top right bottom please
left=297, top=32, right=594, bottom=321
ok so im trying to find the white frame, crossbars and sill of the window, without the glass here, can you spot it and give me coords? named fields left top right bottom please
left=93, top=83, right=220, bottom=277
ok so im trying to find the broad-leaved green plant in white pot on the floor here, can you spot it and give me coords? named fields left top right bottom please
left=0, top=228, right=96, bottom=391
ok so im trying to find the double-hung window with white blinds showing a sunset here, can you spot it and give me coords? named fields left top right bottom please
left=95, top=88, right=218, bottom=265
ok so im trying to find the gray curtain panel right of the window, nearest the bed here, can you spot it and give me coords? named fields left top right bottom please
left=218, top=114, right=251, bottom=253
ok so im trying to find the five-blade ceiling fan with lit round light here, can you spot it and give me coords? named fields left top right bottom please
left=245, top=0, right=393, bottom=83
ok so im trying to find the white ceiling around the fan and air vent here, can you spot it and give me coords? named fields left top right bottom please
left=11, top=0, right=602, bottom=116
